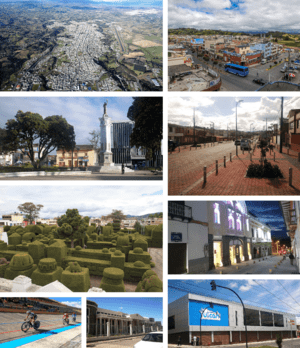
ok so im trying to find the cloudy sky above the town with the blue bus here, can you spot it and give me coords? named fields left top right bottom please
left=168, top=0, right=300, bottom=31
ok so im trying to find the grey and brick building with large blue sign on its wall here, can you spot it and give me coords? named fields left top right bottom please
left=168, top=294, right=297, bottom=346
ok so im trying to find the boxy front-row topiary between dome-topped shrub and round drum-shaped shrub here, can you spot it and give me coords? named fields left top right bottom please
left=61, top=262, right=90, bottom=292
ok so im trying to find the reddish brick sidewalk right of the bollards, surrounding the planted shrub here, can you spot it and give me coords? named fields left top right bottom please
left=169, top=149, right=300, bottom=196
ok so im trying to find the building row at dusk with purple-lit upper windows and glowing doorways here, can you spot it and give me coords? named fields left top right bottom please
left=168, top=201, right=272, bottom=274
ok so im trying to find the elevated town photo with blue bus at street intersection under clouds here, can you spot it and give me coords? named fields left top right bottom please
left=168, top=0, right=300, bottom=91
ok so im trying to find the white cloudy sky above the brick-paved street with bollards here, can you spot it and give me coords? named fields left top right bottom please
left=168, top=95, right=300, bottom=131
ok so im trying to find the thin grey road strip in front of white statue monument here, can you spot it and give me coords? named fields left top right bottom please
left=0, top=173, right=162, bottom=181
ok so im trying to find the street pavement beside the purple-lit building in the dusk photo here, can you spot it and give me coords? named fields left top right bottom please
left=207, top=256, right=297, bottom=274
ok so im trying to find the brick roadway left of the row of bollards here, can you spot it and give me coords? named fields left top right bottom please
left=168, top=141, right=236, bottom=194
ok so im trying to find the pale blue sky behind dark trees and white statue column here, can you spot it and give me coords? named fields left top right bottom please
left=0, top=97, right=133, bottom=145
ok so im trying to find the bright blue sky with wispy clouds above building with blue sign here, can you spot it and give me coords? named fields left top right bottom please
left=168, top=279, right=300, bottom=316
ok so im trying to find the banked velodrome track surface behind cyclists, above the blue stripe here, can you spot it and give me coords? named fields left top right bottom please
left=0, top=312, right=81, bottom=345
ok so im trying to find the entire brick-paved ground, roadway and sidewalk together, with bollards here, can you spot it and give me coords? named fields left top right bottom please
left=169, top=145, right=300, bottom=195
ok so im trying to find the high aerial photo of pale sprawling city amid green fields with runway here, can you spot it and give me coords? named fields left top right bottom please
left=0, top=0, right=163, bottom=91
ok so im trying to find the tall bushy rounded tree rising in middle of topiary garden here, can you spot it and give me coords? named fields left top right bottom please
left=57, top=209, right=88, bottom=248
